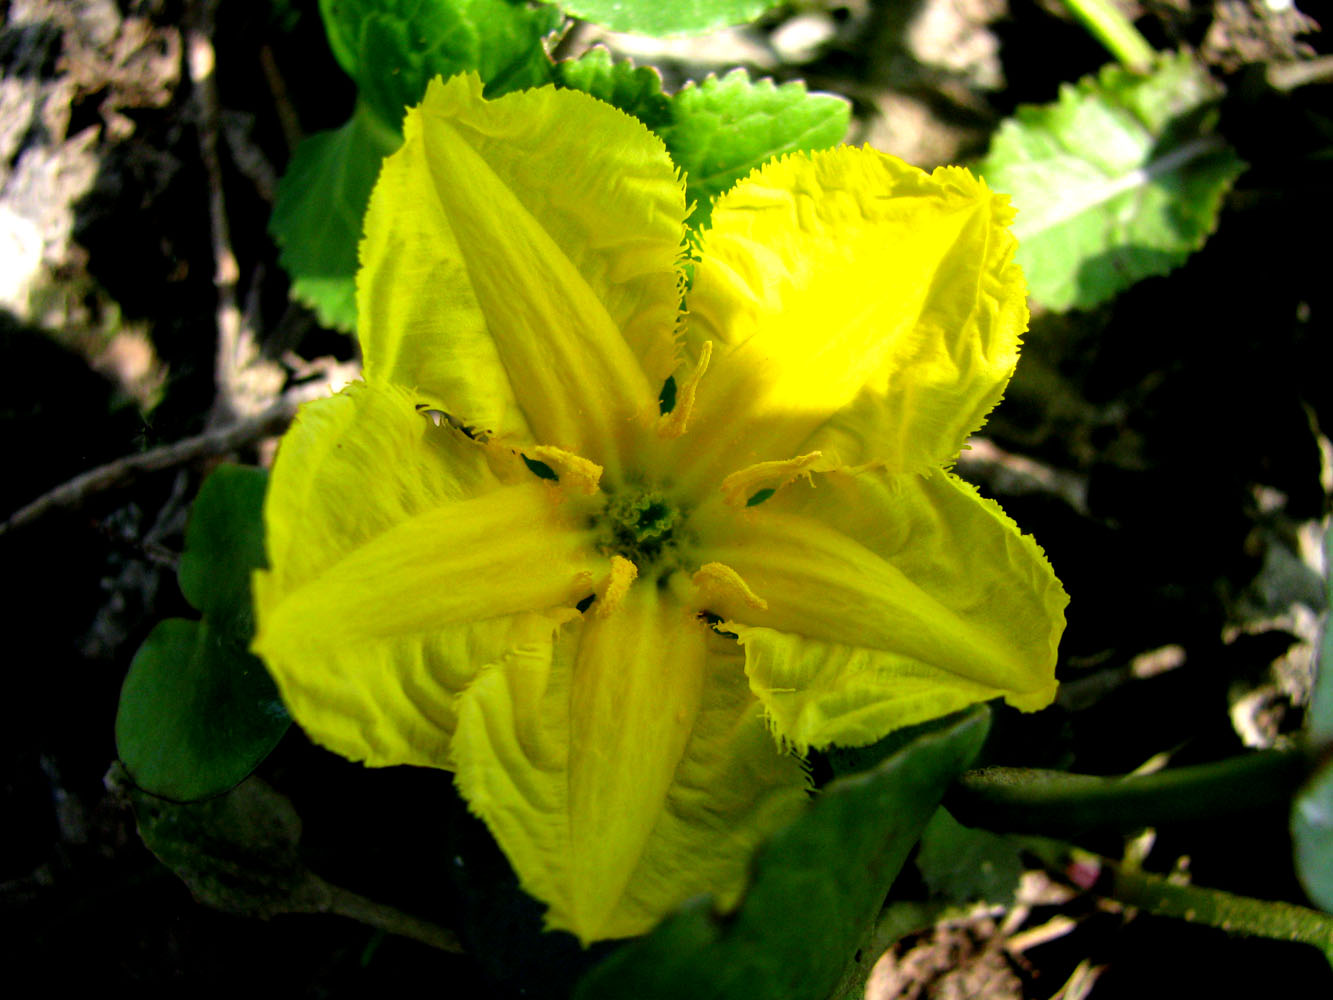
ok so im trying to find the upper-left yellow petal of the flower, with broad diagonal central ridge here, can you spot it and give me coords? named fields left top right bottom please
left=357, top=73, right=685, bottom=461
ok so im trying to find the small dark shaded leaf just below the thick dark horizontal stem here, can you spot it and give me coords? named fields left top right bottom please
left=916, top=809, right=1022, bottom=905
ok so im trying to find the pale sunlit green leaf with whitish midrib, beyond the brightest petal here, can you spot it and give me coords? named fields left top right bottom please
left=978, top=53, right=1245, bottom=309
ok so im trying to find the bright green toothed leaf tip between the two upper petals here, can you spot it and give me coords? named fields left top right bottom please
left=660, top=69, right=850, bottom=228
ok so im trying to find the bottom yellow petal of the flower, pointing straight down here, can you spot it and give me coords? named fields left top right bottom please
left=455, top=585, right=805, bottom=944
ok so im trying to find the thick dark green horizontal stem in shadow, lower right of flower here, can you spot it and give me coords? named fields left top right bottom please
left=945, top=749, right=1312, bottom=837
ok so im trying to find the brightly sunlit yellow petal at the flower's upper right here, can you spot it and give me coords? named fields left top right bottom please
left=686, top=147, right=1028, bottom=483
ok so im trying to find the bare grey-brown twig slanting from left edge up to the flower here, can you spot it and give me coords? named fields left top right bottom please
left=0, top=381, right=329, bottom=536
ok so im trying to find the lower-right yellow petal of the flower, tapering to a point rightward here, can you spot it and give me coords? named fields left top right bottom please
left=700, top=471, right=1068, bottom=751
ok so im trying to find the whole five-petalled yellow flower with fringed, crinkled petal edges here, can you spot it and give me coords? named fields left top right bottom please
left=247, top=76, right=1066, bottom=943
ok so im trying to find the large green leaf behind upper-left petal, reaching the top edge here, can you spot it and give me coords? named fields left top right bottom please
left=282, top=0, right=561, bottom=333
